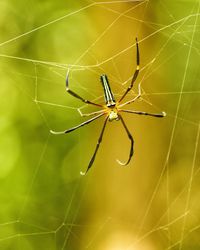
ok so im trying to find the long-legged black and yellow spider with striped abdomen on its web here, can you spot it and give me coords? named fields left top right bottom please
left=50, top=38, right=166, bottom=175
